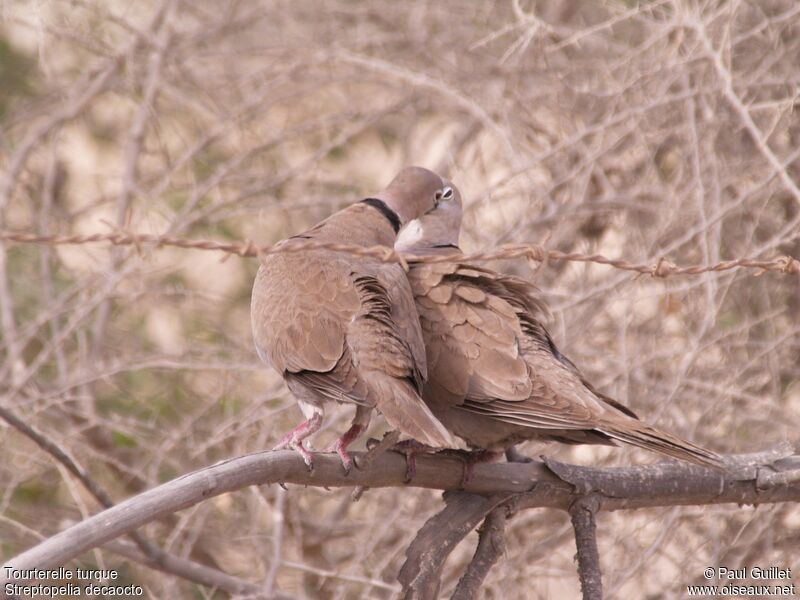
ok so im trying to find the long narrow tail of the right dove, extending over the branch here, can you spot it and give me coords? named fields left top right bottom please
left=595, top=419, right=727, bottom=471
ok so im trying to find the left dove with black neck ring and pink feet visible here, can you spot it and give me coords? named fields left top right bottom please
left=250, top=167, right=454, bottom=472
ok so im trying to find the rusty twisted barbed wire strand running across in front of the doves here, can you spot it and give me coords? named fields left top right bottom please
left=0, top=229, right=800, bottom=278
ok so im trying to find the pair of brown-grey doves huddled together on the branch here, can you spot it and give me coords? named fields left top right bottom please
left=251, top=167, right=722, bottom=472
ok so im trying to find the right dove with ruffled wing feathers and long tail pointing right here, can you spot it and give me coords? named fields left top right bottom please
left=395, top=181, right=723, bottom=476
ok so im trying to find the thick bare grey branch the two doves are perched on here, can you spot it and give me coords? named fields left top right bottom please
left=0, top=449, right=800, bottom=584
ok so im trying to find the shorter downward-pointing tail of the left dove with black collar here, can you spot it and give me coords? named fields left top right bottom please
left=376, top=374, right=458, bottom=448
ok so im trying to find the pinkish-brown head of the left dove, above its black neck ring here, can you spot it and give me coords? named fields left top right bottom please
left=375, top=167, right=445, bottom=226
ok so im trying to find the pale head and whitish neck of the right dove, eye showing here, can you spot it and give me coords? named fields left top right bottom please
left=394, top=179, right=461, bottom=252
